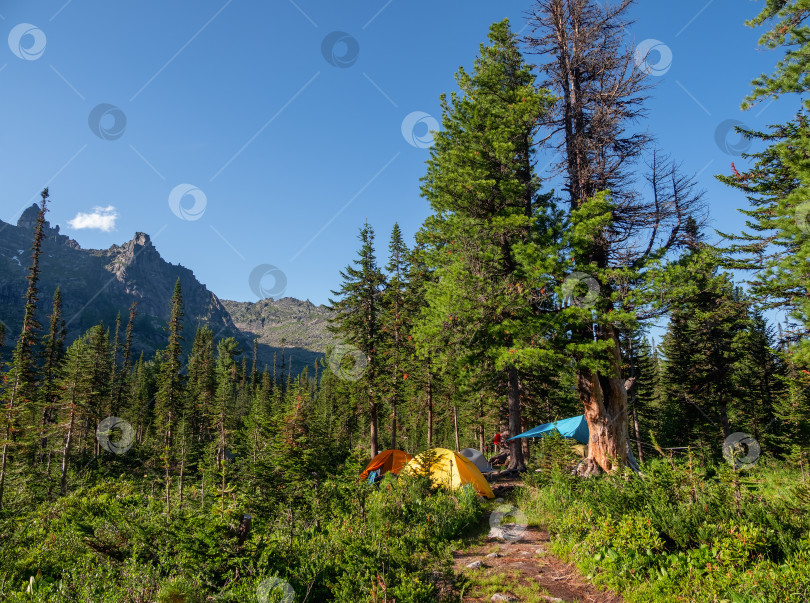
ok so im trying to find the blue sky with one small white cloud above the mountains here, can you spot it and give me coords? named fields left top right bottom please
left=0, top=0, right=796, bottom=303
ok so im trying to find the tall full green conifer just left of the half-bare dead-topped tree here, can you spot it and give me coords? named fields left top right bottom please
left=416, top=20, right=550, bottom=469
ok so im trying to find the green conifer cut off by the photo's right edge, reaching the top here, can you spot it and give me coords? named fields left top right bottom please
left=718, top=0, right=810, bottom=366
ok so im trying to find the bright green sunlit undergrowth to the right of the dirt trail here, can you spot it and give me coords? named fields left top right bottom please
left=518, top=440, right=810, bottom=603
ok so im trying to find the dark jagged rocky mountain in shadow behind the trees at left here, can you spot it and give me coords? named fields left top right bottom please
left=0, top=205, right=322, bottom=371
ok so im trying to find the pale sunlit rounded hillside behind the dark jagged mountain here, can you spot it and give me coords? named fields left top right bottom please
left=222, top=297, right=332, bottom=353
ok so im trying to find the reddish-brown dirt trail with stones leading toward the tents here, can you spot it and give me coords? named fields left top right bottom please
left=453, top=527, right=622, bottom=603
